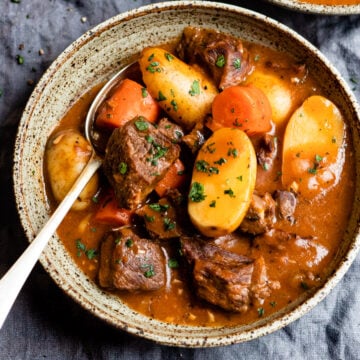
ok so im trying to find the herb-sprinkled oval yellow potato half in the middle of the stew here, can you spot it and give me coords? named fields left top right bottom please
left=188, top=128, right=257, bottom=237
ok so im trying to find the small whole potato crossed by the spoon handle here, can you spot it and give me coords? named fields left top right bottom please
left=45, top=130, right=99, bottom=210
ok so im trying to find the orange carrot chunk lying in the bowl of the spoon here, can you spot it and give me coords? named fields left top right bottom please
left=96, top=79, right=160, bottom=128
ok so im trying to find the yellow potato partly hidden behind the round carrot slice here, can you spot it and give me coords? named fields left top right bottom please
left=247, top=70, right=293, bottom=125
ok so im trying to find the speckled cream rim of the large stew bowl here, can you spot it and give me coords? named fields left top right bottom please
left=13, top=1, right=360, bottom=347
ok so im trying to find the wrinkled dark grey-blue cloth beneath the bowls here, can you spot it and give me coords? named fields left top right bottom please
left=0, top=0, right=360, bottom=360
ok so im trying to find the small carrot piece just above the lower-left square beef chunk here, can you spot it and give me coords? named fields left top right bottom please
left=94, top=193, right=132, bottom=226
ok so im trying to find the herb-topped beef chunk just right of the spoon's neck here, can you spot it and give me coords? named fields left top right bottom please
left=103, top=117, right=180, bottom=209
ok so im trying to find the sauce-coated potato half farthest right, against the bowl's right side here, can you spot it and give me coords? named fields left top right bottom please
left=282, top=95, right=345, bottom=199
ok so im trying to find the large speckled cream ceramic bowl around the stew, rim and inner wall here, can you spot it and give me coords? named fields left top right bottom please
left=14, top=1, right=360, bottom=347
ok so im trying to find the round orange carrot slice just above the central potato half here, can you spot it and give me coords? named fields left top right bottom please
left=207, top=85, right=271, bottom=136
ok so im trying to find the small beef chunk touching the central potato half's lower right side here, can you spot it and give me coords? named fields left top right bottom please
left=240, top=193, right=276, bottom=235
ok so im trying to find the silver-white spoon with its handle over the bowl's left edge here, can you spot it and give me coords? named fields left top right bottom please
left=0, top=63, right=135, bottom=329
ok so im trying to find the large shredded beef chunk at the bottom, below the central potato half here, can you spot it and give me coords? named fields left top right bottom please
left=181, top=237, right=279, bottom=312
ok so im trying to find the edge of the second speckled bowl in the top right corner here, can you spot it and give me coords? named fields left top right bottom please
left=267, top=0, right=360, bottom=15
